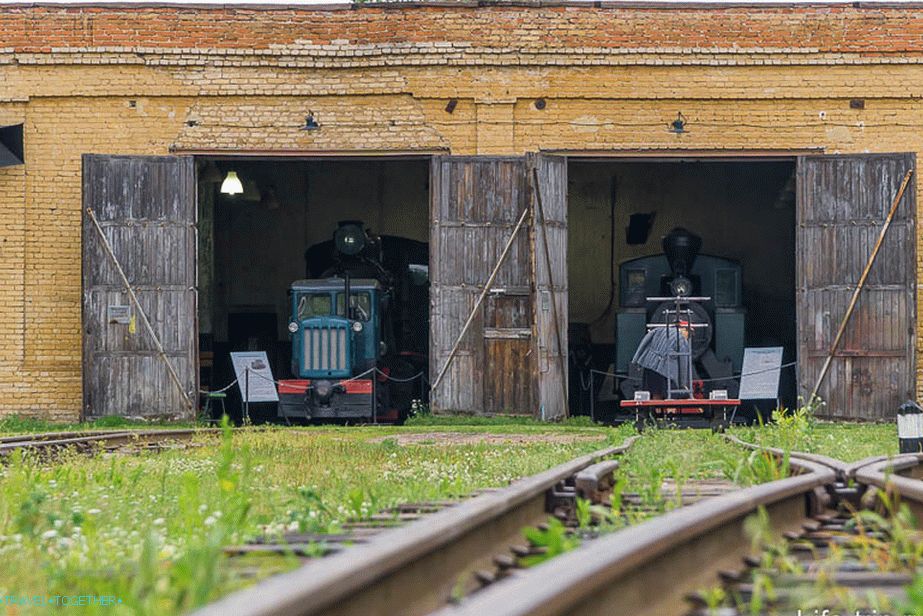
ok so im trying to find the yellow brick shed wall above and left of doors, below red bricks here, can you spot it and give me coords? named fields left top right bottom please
left=0, top=45, right=923, bottom=420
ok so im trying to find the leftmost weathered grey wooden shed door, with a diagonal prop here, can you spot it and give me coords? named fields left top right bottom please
left=83, top=155, right=197, bottom=418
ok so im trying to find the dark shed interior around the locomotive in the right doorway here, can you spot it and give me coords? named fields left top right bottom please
left=568, top=159, right=796, bottom=414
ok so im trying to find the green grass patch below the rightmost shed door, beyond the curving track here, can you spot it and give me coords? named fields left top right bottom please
left=732, top=408, right=898, bottom=462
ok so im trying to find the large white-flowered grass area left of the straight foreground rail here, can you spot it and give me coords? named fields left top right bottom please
left=0, top=418, right=629, bottom=614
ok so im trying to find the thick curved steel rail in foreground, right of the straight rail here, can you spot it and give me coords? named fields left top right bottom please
left=438, top=458, right=837, bottom=616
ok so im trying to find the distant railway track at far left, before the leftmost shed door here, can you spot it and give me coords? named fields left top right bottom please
left=0, top=428, right=212, bottom=458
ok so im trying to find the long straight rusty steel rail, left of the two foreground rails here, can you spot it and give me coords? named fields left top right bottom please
left=194, top=436, right=638, bottom=616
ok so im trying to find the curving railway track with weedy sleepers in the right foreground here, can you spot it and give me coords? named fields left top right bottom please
left=439, top=440, right=923, bottom=616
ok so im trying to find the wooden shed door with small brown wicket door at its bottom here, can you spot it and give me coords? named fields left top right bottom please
left=430, top=156, right=536, bottom=415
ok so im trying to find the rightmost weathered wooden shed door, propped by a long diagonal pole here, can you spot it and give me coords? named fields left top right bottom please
left=796, top=154, right=916, bottom=419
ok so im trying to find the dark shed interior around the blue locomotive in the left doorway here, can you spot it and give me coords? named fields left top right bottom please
left=197, top=157, right=429, bottom=418
